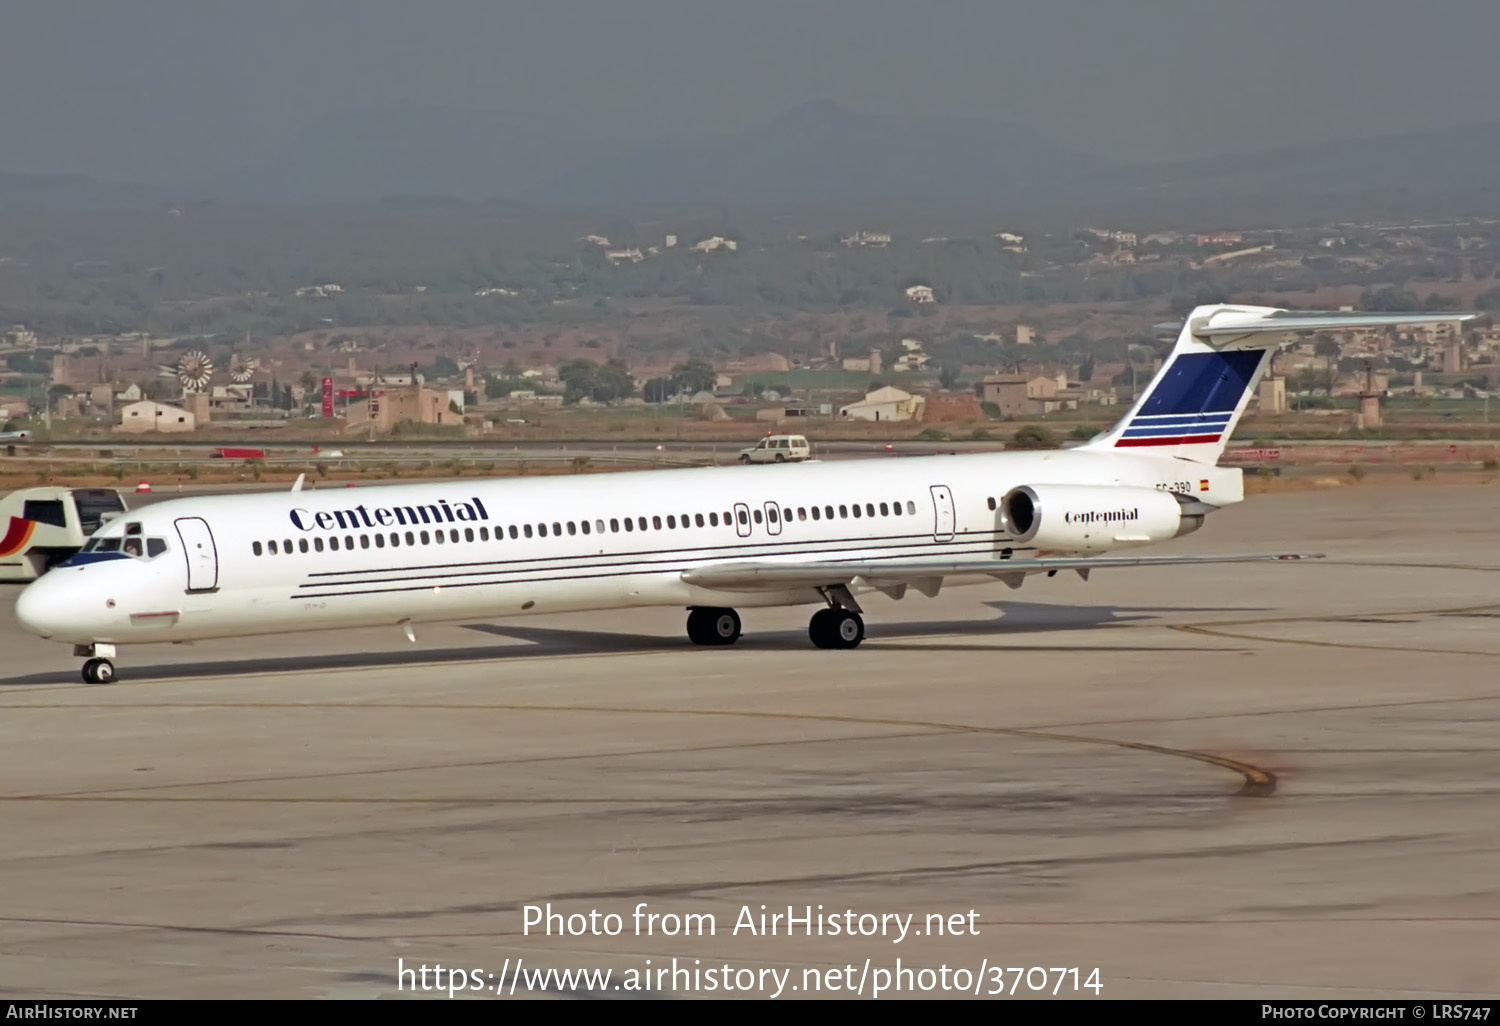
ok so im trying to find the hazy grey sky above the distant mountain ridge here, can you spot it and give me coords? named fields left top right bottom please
left=0, top=0, right=1500, bottom=182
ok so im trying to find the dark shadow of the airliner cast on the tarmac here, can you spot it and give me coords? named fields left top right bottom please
left=0, top=602, right=1260, bottom=689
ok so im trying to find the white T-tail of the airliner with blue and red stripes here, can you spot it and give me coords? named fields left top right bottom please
left=1085, top=306, right=1481, bottom=464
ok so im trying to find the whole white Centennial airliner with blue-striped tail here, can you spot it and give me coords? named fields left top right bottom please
left=15, top=306, right=1478, bottom=683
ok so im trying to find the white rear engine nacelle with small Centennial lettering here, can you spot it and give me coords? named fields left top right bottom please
left=1001, top=485, right=1217, bottom=552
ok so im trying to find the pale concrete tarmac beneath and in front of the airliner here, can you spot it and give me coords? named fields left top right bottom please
left=0, top=483, right=1500, bottom=1001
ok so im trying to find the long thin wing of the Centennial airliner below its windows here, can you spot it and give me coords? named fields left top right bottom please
left=683, top=554, right=1323, bottom=599
